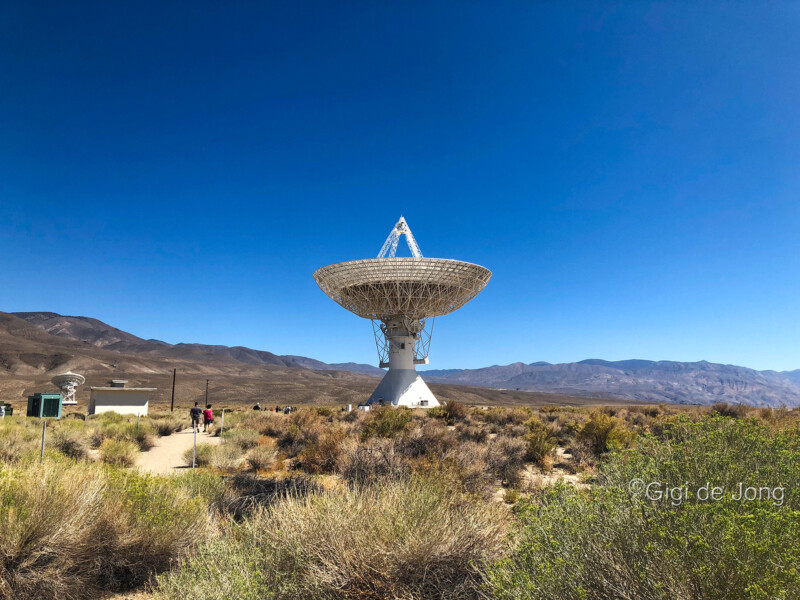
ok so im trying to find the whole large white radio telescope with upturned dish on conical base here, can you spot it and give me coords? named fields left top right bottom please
left=314, top=216, right=492, bottom=407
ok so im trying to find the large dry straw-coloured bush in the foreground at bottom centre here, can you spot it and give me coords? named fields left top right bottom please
left=159, top=477, right=507, bottom=600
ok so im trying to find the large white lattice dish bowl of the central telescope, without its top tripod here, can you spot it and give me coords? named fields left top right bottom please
left=314, top=257, right=492, bottom=321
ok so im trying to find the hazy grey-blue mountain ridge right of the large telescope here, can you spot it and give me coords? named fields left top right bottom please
left=422, top=359, right=800, bottom=407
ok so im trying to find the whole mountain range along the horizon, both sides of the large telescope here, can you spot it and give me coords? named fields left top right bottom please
left=0, top=312, right=800, bottom=406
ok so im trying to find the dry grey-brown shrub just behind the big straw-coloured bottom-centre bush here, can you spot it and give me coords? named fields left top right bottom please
left=339, top=438, right=411, bottom=484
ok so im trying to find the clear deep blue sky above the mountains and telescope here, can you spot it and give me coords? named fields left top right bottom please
left=0, top=1, right=800, bottom=370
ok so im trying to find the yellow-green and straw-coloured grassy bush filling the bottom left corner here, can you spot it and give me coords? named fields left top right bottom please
left=0, top=458, right=209, bottom=600
